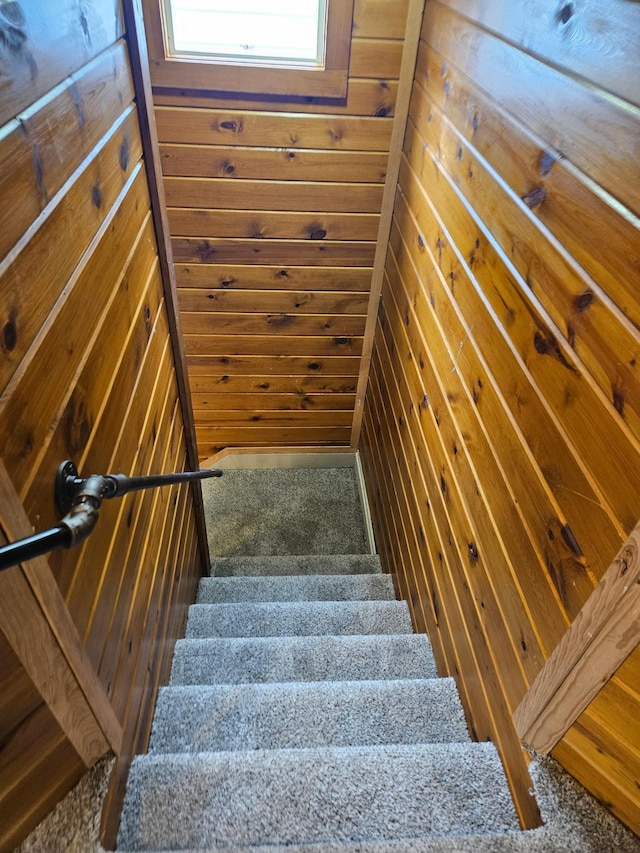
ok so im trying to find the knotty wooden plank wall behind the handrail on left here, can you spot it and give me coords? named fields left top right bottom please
left=0, top=0, right=199, bottom=851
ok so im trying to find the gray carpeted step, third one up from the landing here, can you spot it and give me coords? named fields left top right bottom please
left=186, top=601, right=413, bottom=639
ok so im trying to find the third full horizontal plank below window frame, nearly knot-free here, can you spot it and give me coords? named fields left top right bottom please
left=164, top=178, right=382, bottom=213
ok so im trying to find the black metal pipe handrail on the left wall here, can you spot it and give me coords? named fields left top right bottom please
left=0, top=460, right=222, bottom=571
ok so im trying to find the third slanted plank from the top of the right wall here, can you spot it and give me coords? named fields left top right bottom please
left=416, top=44, right=640, bottom=326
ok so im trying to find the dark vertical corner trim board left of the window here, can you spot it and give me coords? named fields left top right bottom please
left=122, top=0, right=209, bottom=574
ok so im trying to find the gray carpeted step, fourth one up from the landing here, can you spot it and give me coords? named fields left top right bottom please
left=171, top=634, right=437, bottom=684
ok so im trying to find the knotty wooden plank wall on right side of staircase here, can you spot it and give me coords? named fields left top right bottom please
left=361, top=0, right=640, bottom=832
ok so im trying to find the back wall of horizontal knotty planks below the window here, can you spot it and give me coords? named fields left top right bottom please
left=149, top=0, right=408, bottom=458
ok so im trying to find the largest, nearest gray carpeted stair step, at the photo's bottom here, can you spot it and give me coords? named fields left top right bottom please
left=118, top=743, right=518, bottom=850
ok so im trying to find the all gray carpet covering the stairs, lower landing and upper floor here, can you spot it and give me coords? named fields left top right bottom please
left=21, top=469, right=640, bottom=853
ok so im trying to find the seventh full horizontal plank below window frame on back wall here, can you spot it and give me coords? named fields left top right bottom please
left=179, top=288, right=367, bottom=316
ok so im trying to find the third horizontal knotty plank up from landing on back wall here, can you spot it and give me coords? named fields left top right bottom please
left=193, top=388, right=356, bottom=410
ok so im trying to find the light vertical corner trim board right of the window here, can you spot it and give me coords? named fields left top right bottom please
left=351, top=0, right=424, bottom=448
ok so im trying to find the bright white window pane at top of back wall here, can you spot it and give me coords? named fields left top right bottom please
left=165, top=0, right=326, bottom=66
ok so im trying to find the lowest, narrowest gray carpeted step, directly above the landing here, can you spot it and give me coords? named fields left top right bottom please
left=211, top=554, right=382, bottom=577
